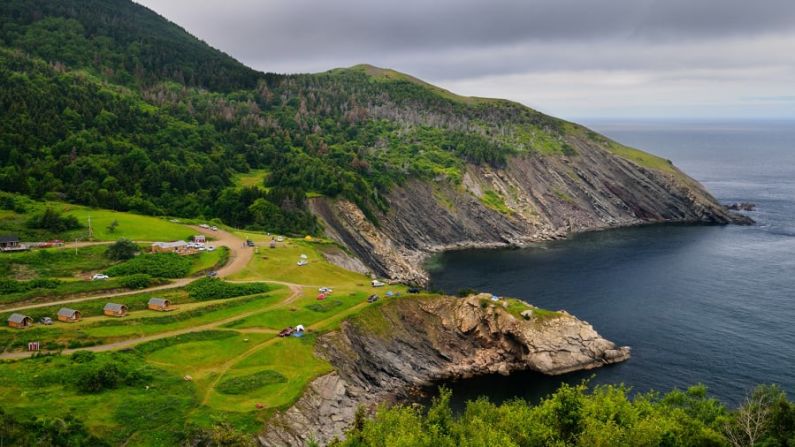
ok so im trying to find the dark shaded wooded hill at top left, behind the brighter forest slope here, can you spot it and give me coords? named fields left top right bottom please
left=0, top=0, right=260, bottom=91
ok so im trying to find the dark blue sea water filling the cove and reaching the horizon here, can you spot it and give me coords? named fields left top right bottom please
left=432, top=122, right=795, bottom=404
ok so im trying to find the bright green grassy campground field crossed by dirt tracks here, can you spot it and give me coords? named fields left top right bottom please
left=0, top=229, right=416, bottom=446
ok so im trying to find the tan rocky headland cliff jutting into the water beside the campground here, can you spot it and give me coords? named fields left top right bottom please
left=259, top=296, right=629, bottom=446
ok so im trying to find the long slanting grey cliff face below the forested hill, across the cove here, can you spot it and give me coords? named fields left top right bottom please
left=311, top=133, right=743, bottom=283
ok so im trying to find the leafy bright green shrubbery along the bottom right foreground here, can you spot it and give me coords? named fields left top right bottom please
left=334, top=385, right=795, bottom=447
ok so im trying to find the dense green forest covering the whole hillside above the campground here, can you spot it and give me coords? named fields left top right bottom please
left=0, top=0, right=581, bottom=233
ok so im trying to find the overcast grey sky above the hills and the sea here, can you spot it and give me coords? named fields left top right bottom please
left=138, top=0, right=795, bottom=119
